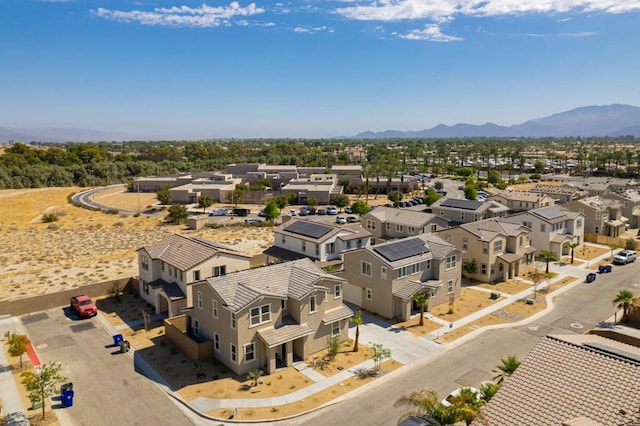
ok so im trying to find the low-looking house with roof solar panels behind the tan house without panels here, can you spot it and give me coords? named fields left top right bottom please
left=427, top=198, right=509, bottom=226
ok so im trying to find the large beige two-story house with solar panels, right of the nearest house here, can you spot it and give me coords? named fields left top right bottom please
left=340, top=234, right=462, bottom=320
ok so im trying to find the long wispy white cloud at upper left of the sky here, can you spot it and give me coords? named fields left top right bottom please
left=91, top=1, right=265, bottom=28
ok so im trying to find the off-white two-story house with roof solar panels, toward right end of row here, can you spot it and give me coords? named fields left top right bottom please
left=503, top=206, right=584, bottom=259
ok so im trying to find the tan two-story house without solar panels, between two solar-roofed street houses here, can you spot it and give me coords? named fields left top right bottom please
left=438, top=219, right=536, bottom=282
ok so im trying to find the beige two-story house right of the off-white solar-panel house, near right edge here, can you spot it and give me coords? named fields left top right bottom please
left=563, top=196, right=629, bottom=237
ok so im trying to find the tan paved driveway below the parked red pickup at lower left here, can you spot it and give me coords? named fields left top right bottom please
left=20, top=308, right=193, bottom=425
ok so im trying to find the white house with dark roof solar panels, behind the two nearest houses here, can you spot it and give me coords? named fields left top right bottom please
left=264, top=219, right=371, bottom=264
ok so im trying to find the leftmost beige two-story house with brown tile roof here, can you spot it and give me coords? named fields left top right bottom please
left=138, top=234, right=251, bottom=316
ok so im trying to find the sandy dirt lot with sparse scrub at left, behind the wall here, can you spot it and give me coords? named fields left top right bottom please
left=0, top=188, right=273, bottom=300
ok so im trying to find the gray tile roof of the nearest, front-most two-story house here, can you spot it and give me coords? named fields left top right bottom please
left=205, top=258, right=345, bottom=312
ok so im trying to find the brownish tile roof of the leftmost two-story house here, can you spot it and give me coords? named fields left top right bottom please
left=138, top=234, right=250, bottom=271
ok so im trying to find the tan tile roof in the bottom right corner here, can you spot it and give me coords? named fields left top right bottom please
left=473, top=335, right=640, bottom=426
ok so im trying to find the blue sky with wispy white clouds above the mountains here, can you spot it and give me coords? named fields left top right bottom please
left=0, top=0, right=640, bottom=138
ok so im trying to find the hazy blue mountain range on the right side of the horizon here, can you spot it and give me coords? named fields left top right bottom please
left=353, top=104, right=640, bottom=139
